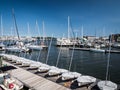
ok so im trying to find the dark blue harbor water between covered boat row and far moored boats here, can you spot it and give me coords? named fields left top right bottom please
left=1, top=40, right=120, bottom=84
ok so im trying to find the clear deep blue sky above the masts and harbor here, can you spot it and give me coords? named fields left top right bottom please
left=0, top=0, right=120, bottom=37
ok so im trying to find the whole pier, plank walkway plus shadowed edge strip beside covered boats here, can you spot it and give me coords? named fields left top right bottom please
left=3, top=61, right=89, bottom=90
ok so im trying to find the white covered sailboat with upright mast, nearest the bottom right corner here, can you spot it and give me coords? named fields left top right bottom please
left=97, top=34, right=117, bottom=90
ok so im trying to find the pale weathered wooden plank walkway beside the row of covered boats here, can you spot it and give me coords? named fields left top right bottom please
left=3, top=61, right=70, bottom=90
